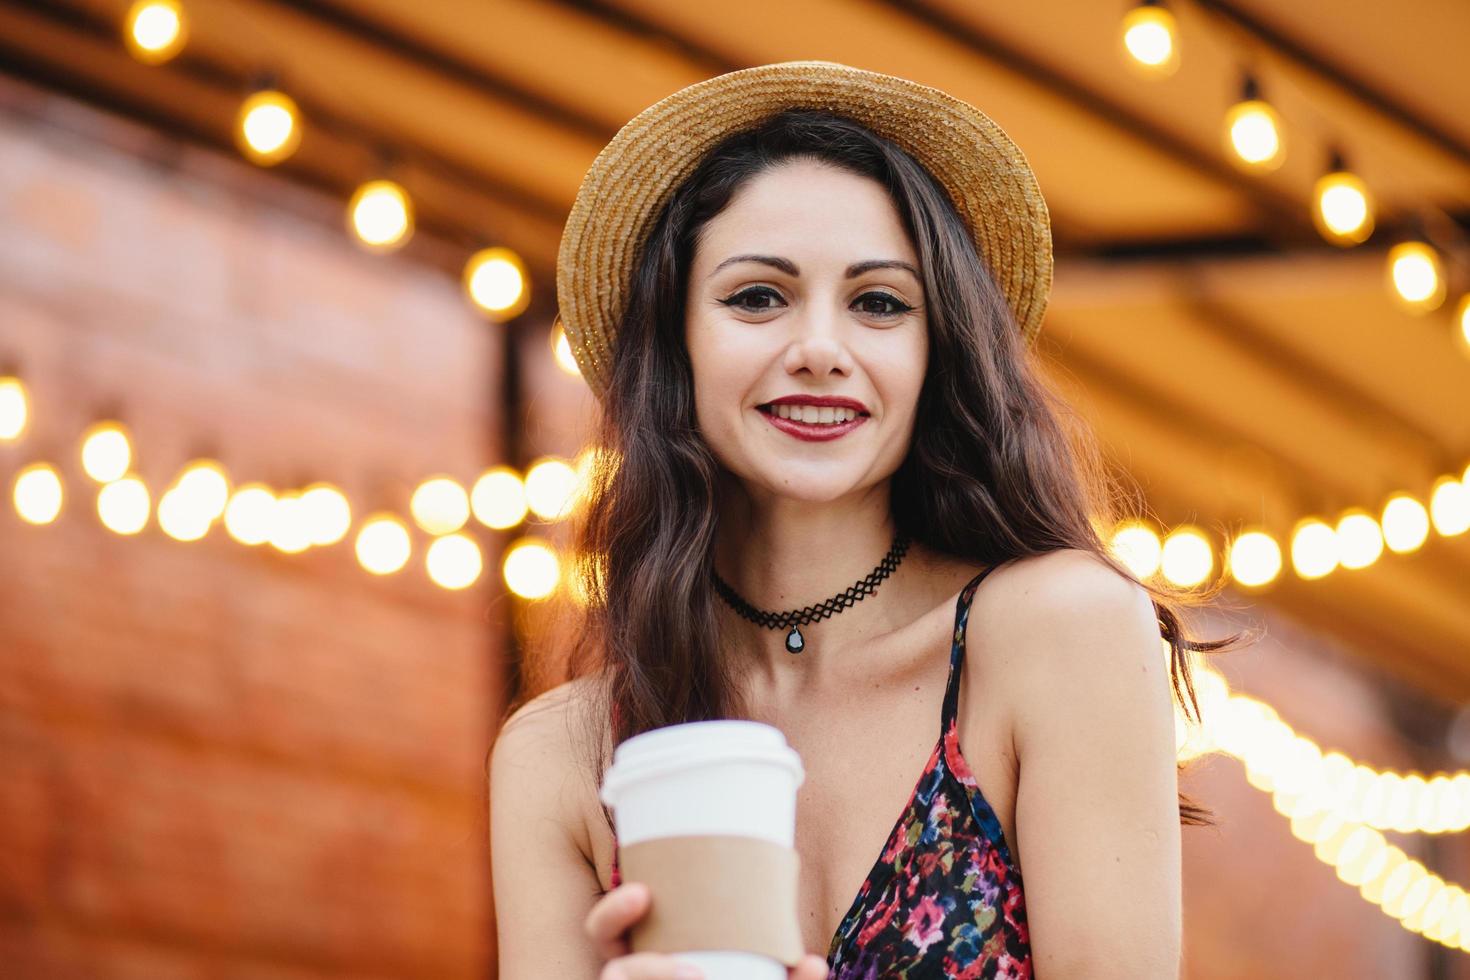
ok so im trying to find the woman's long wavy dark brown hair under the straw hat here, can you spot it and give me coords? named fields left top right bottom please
left=507, top=110, right=1241, bottom=824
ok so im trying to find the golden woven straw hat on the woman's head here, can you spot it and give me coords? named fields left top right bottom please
left=556, top=62, right=1051, bottom=398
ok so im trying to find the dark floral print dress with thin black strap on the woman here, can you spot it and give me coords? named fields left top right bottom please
left=612, top=566, right=1032, bottom=980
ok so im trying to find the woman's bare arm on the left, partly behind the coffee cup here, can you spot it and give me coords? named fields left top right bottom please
left=488, top=682, right=603, bottom=980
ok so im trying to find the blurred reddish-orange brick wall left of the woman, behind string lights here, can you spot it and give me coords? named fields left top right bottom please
left=0, top=82, right=509, bottom=979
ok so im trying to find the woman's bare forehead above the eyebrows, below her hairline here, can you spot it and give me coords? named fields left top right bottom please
left=694, top=160, right=917, bottom=267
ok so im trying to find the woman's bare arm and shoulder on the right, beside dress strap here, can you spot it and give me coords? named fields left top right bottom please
left=987, top=550, right=1183, bottom=980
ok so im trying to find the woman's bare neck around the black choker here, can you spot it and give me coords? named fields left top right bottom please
left=714, top=482, right=913, bottom=683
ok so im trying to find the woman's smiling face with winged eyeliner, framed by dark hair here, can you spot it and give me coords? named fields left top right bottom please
left=685, top=160, right=929, bottom=501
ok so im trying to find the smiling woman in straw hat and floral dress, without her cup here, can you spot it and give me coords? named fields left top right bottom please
left=490, top=62, right=1223, bottom=980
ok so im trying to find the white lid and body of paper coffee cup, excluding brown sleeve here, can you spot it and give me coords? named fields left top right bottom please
left=600, top=718, right=806, bottom=980
